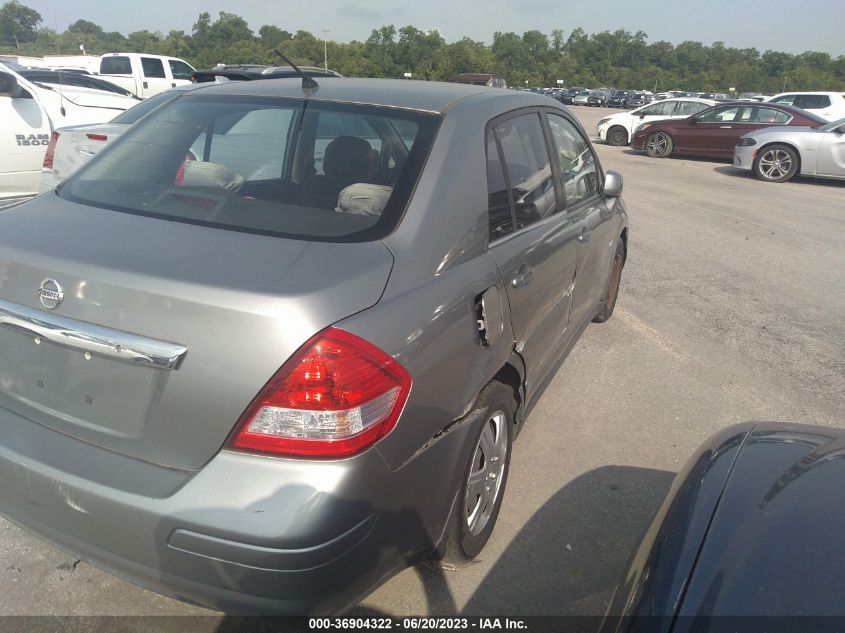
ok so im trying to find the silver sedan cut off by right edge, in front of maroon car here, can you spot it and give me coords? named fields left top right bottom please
left=734, top=119, right=845, bottom=182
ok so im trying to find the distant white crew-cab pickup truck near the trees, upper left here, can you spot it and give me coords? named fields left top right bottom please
left=95, top=53, right=194, bottom=99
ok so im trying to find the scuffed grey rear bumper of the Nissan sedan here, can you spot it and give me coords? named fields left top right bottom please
left=0, top=408, right=462, bottom=614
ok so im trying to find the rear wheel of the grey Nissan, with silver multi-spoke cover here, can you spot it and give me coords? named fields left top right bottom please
left=436, top=382, right=516, bottom=566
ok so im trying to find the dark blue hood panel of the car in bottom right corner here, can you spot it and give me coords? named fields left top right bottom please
left=679, top=423, right=845, bottom=616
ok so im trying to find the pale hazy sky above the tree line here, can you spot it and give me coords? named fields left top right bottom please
left=23, top=0, right=845, bottom=57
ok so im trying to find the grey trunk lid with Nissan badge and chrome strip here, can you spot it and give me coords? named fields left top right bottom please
left=0, top=193, right=393, bottom=470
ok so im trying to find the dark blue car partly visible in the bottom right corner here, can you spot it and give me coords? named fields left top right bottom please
left=601, top=422, right=845, bottom=633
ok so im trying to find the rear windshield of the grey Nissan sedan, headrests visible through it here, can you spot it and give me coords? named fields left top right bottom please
left=59, top=95, right=440, bottom=242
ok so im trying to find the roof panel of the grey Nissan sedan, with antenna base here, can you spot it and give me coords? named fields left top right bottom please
left=185, top=77, right=520, bottom=114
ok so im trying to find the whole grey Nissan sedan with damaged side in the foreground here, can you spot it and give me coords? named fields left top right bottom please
left=0, top=78, right=628, bottom=613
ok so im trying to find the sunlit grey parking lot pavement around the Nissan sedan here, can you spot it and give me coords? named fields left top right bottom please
left=0, top=107, right=845, bottom=615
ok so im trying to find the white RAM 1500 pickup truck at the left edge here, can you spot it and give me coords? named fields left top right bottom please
left=0, top=64, right=138, bottom=200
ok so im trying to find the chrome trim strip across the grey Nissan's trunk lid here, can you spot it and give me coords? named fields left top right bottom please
left=0, top=299, right=188, bottom=370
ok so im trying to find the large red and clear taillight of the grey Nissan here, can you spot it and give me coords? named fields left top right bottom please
left=229, top=327, right=411, bottom=458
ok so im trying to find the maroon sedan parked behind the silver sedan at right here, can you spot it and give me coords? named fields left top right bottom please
left=631, top=101, right=826, bottom=158
